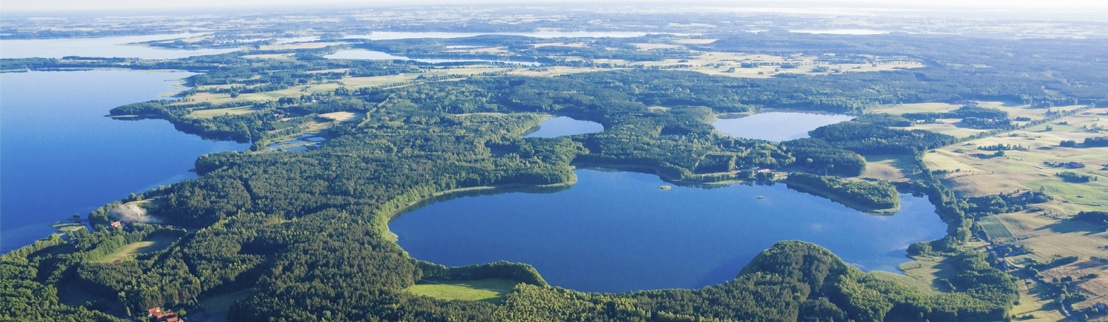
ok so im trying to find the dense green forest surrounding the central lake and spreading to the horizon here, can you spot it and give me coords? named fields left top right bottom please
left=8, top=15, right=1108, bottom=321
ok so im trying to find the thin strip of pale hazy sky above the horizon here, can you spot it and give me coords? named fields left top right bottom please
left=0, top=0, right=1108, bottom=13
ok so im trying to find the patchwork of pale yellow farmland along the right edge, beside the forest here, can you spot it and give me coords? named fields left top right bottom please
left=868, top=102, right=1108, bottom=312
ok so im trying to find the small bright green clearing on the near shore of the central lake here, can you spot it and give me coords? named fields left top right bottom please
left=408, top=279, right=517, bottom=304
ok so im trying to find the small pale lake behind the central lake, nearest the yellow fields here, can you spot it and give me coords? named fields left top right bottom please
left=711, top=112, right=854, bottom=142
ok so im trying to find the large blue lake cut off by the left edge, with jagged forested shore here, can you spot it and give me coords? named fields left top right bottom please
left=0, top=71, right=247, bottom=252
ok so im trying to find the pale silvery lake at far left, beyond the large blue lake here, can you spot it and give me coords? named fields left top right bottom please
left=0, top=33, right=235, bottom=60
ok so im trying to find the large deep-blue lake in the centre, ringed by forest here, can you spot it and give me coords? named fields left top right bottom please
left=389, top=169, right=946, bottom=292
